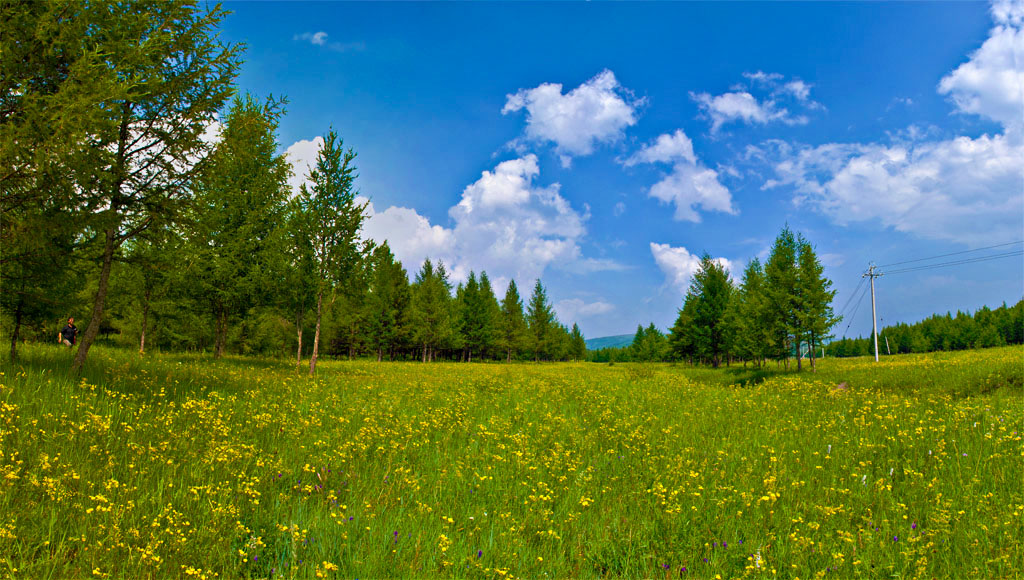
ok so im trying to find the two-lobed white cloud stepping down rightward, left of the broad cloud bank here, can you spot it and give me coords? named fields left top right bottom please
left=624, top=129, right=736, bottom=221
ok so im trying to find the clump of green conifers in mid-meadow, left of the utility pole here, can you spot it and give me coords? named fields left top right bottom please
left=589, top=226, right=840, bottom=370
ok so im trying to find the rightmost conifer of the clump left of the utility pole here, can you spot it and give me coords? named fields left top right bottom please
left=797, top=238, right=839, bottom=369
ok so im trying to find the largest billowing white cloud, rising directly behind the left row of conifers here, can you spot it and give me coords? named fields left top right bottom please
left=286, top=142, right=625, bottom=287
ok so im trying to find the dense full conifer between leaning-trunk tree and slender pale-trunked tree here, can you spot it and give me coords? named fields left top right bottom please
left=191, top=94, right=291, bottom=358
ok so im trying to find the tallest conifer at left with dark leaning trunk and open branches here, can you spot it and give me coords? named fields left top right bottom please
left=69, top=0, right=241, bottom=372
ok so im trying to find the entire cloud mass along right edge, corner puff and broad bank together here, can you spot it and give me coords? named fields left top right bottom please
left=763, top=1, right=1024, bottom=245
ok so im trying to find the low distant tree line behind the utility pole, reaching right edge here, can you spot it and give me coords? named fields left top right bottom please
left=825, top=300, right=1024, bottom=357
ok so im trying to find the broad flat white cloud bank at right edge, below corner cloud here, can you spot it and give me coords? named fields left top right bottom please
left=765, top=135, right=1024, bottom=244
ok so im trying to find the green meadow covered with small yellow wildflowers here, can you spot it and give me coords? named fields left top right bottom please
left=0, top=345, right=1024, bottom=579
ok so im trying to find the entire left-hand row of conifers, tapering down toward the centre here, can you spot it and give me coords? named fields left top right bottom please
left=0, top=0, right=586, bottom=373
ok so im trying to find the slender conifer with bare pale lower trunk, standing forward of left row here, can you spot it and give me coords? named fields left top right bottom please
left=298, top=130, right=368, bottom=376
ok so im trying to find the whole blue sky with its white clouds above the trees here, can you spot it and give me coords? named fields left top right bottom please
left=221, top=2, right=1024, bottom=337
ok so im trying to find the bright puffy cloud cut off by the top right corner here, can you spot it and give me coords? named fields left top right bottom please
left=939, top=1, right=1024, bottom=130
